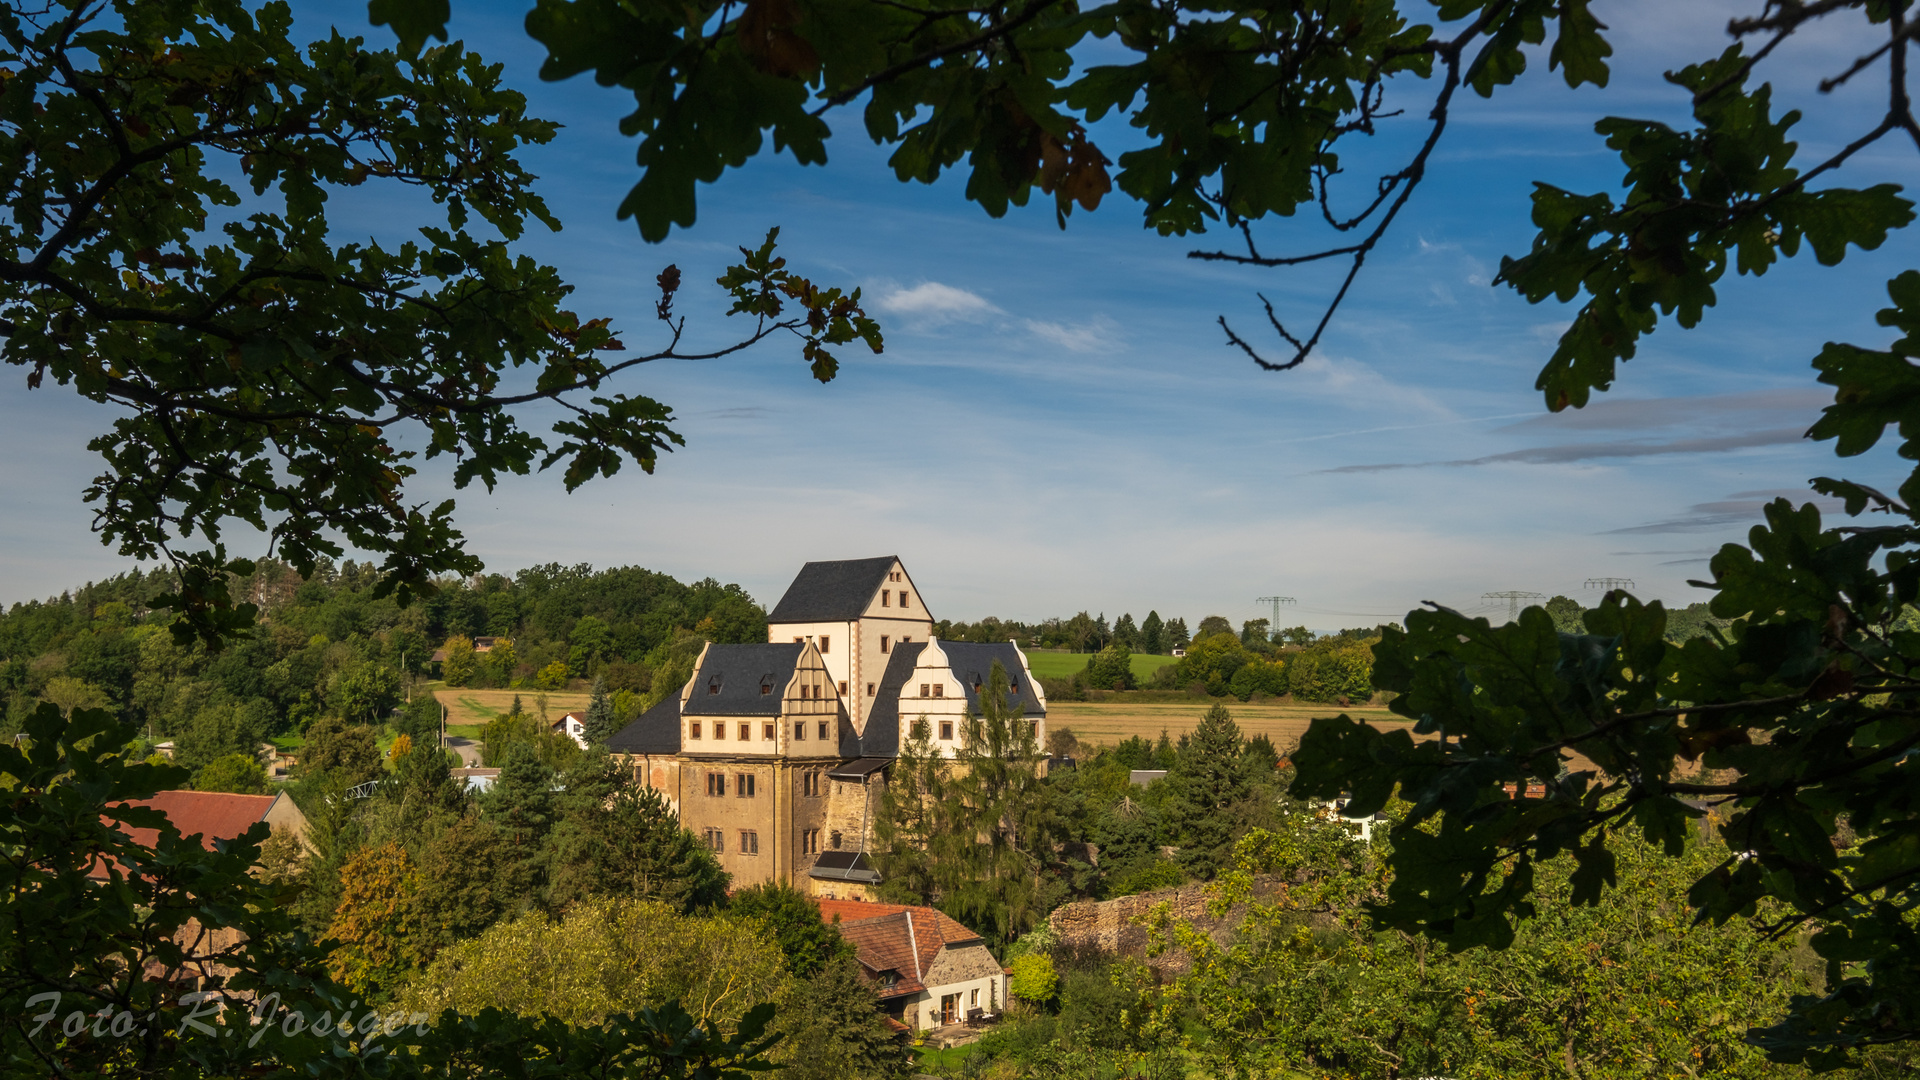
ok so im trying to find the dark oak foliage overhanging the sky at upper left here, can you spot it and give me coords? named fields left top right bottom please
left=0, top=0, right=881, bottom=640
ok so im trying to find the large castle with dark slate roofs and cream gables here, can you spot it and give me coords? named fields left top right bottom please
left=609, top=555, right=1046, bottom=899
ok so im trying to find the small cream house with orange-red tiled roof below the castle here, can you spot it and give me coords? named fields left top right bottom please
left=818, top=899, right=1006, bottom=1030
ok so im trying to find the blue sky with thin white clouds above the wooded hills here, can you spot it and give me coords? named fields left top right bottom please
left=0, top=0, right=1914, bottom=628
